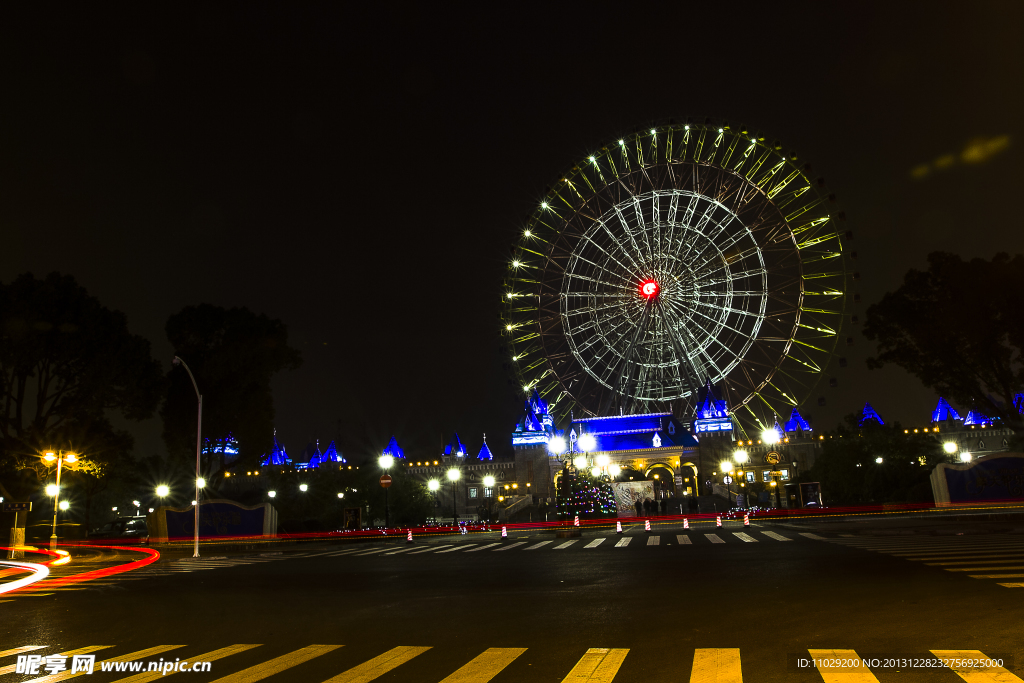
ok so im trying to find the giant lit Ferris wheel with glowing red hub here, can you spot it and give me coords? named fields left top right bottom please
left=502, top=121, right=852, bottom=428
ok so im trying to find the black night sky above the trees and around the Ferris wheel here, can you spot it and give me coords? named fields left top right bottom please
left=0, top=2, right=1024, bottom=457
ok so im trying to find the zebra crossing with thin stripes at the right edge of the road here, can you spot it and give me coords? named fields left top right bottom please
left=827, top=535, right=1024, bottom=588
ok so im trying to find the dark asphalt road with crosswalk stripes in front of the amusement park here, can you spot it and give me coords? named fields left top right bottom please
left=0, top=522, right=1024, bottom=683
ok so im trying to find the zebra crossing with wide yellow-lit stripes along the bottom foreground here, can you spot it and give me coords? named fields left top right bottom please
left=0, top=644, right=1011, bottom=683
